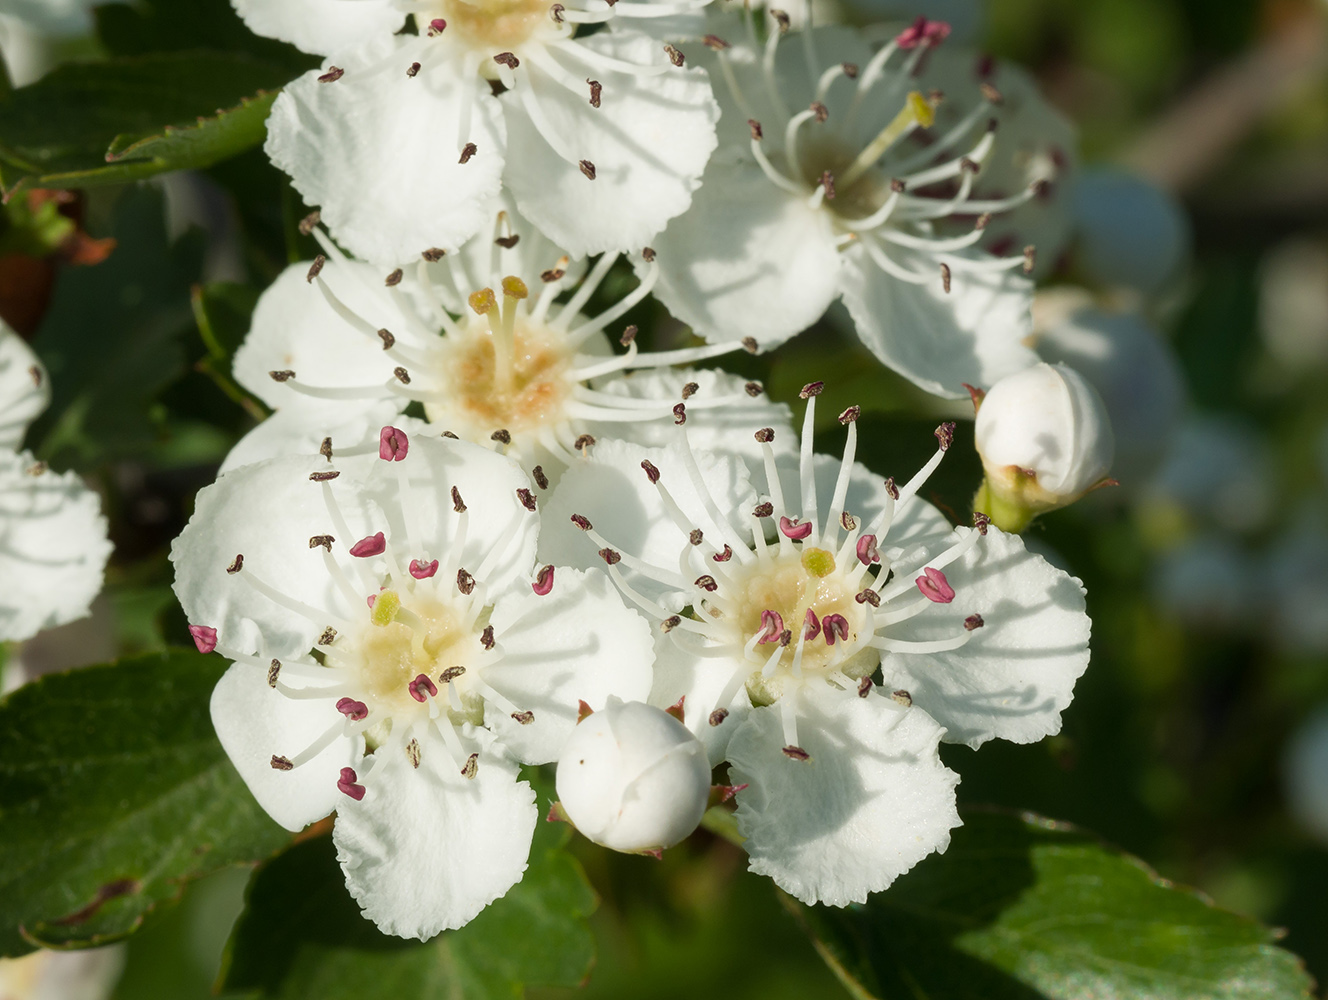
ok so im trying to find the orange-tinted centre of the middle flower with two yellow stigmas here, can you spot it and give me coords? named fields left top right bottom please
left=425, top=316, right=574, bottom=441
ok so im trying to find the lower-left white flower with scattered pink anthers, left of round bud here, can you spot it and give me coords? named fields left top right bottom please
left=171, top=426, right=652, bottom=939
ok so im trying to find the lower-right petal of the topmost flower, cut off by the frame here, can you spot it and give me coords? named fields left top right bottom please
left=501, top=32, right=720, bottom=254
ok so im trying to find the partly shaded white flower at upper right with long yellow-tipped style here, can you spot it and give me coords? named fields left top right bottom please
left=652, top=13, right=1073, bottom=397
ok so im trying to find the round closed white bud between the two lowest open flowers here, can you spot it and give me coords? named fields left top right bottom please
left=558, top=697, right=710, bottom=853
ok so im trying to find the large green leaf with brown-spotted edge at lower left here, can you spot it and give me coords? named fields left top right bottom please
left=0, top=649, right=290, bottom=955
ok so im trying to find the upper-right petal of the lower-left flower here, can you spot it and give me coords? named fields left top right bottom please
left=371, top=434, right=539, bottom=600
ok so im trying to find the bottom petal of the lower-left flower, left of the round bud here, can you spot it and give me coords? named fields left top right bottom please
left=332, top=730, right=538, bottom=940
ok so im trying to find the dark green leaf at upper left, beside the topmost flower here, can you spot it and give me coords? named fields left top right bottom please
left=0, top=52, right=292, bottom=198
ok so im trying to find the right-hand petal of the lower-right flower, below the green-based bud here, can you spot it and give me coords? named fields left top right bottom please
left=880, top=527, right=1090, bottom=748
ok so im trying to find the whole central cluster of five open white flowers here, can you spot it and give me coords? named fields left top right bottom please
left=171, top=0, right=1109, bottom=938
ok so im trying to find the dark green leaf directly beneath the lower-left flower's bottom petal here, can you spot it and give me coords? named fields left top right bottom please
left=222, top=807, right=596, bottom=1000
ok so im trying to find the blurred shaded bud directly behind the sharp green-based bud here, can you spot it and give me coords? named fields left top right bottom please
left=1033, top=293, right=1185, bottom=490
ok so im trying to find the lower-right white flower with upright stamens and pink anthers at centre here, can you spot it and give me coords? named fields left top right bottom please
left=542, top=384, right=1089, bottom=906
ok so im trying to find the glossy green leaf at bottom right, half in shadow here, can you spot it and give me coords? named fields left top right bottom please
left=786, top=813, right=1311, bottom=1000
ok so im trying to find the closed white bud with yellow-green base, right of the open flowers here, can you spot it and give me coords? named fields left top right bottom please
left=975, top=364, right=1114, bottom=531
